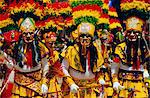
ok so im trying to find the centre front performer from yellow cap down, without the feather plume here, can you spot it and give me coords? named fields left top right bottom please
left=62, top=22, right=104, bottom=98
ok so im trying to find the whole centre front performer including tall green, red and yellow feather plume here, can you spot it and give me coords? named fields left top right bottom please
left=62, top=0, right=104, bottom=98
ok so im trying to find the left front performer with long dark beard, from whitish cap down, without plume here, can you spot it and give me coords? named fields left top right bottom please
left=12, top=17, right=48, bottom=98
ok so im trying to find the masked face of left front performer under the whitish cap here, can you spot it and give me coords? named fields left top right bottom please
left=23, top=32, right=34, bottom=43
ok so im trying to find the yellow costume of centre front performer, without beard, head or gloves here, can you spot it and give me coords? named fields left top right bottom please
left=62, top=44, right=104, bottom=98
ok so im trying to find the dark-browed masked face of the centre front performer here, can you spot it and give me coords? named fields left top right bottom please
left=79, top=34, right=92, bottom=47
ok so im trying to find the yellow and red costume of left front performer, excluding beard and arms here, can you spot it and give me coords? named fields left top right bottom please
left=12, top=42, right=47, bottom=98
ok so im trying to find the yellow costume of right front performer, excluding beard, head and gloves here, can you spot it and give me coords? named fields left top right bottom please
left=115, top=42, right=148, bottom=98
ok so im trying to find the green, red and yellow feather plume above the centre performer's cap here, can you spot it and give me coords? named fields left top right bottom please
left=70, top=0, right=103, bottom=25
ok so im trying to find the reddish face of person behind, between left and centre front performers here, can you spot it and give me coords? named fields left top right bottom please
left=43, top=32, right=57, bottom=49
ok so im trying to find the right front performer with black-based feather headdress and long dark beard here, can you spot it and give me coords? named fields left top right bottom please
left=112, top=0, right=149, bottom=98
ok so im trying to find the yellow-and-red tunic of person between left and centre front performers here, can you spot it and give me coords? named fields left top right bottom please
left=47, top=51, right=63, bottom=98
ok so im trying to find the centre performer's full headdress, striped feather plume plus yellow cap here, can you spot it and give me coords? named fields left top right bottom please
left=69, top=0, right=107, bottom=36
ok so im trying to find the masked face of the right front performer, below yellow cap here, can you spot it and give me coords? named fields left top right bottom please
left=126, top=30, right=140, bottom=41
